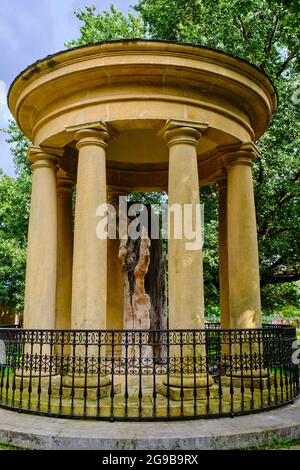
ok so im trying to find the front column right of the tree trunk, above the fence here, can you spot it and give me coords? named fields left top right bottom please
left=160, top=121, right=207, bottom=329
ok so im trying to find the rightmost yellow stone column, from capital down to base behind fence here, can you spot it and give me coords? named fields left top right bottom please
left=221, top=143, right=274, bottom=390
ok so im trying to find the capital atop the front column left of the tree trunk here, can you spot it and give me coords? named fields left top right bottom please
left=65, top=121, right=117, bottom=150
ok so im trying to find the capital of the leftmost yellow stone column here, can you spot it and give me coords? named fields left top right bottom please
left=27, top=145, right=64, bottom=171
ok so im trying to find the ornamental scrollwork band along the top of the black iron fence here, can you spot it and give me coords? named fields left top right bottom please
left=0, top=325, right=297, bottom=345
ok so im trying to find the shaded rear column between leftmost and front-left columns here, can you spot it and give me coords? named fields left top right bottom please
left=55, top=170, right=74, bottom=330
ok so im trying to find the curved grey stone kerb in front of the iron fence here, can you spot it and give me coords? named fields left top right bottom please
left=0, top=399, right=300, bottom=450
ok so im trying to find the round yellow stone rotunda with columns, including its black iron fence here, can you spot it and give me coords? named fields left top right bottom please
left=0, top=40, right=299, bottom=419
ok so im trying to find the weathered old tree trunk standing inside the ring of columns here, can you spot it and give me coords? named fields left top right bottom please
left=119, top=228, right=167, bottom=364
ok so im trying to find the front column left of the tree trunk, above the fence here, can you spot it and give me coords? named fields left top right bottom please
left=72, top=125, right=110, bottom=330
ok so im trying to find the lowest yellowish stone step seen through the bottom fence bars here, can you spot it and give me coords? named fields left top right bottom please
left=1, top=387, right=296, bottom=419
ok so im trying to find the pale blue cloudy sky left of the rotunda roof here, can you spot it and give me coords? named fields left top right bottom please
left=0, top=0, right=136, bottom=175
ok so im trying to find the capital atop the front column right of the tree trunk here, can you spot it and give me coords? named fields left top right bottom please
left=158, top=119, right=208, bottom=147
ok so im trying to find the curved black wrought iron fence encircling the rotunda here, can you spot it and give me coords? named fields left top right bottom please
left=0, top=326, right=299, bottom=420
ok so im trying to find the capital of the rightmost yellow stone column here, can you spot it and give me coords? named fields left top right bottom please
left=219, top=142, right=260, bottom=168
